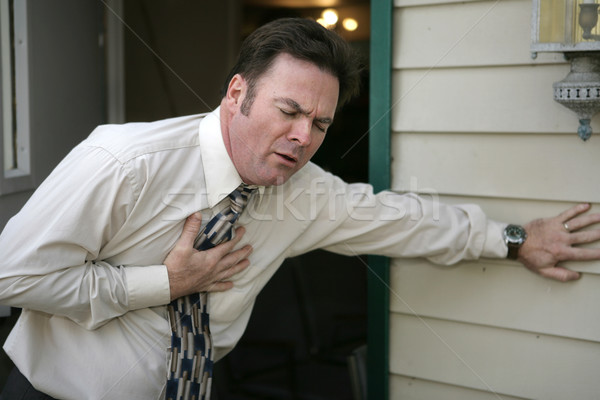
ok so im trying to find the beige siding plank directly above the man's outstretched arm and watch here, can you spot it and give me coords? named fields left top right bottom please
left=392, top=133, right=600, bottom=203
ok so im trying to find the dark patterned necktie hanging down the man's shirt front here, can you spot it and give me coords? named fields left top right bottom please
left=166, top=183, right=256, bottom=400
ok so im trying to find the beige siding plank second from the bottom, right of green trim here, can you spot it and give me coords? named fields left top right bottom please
left=390, top=314, right=600, bottom=400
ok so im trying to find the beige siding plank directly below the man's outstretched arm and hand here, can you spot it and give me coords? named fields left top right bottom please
left=390, top=259, right=600, bottom=342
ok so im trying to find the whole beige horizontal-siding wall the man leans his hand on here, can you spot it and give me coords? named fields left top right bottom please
left=390, top=0, right=600, bottom=400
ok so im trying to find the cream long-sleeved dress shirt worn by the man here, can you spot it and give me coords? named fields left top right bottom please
left=0, top=109, right=507, bottom=400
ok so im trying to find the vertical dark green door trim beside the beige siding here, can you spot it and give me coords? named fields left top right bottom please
left=367, top=0, right=393, bottom=400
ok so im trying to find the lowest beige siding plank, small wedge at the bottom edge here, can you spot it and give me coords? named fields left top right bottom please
left=390, top=375, right=523, bottom=400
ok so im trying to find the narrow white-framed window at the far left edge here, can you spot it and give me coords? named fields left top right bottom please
left=0, top=0, right=31, bottom=194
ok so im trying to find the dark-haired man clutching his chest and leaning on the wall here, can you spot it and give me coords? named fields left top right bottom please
left=0, top=19, right=600, bottom=400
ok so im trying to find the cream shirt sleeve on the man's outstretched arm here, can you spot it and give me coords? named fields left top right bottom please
left=292, top=164, right=507, bottom=264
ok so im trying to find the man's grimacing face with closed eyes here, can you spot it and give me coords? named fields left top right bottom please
left=221, top=54, right=339, bottom=186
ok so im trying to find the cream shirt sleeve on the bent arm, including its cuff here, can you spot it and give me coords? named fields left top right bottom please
left=0, top=145, right=169, bottom=329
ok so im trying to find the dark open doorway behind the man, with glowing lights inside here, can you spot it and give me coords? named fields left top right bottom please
left=123, top=0, right=370, bottom=400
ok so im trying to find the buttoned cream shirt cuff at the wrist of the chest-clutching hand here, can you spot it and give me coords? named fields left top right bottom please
left=125, top=265, right=171, bottom=310
